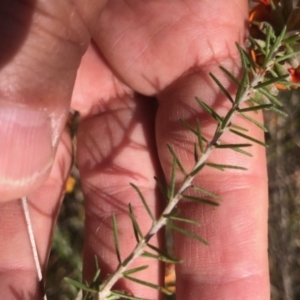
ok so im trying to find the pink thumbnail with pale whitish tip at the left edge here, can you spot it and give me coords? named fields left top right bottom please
left=0, top=104, right=54, bottom=200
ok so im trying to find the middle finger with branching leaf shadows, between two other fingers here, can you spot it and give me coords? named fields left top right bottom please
left=74, top=45, right=161, bottom=299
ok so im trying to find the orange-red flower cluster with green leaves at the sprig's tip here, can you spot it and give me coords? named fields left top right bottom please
left=246, top=0, right=300, bottom=90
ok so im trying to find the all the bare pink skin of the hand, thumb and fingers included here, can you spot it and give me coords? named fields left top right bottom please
left=0, top=0, right=270, bottom=300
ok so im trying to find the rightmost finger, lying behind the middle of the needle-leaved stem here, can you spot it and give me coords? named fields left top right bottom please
left=157, top=60, right=269, bottom=300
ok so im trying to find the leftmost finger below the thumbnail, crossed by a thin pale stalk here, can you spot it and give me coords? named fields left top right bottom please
left=0, top=133, right=71, bottom=300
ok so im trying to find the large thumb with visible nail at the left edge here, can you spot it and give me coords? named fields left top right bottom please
left=0, top=0, right=98, bottom=201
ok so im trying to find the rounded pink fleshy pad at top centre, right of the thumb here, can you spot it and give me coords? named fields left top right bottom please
left=93, top=0, right=248, bottom=95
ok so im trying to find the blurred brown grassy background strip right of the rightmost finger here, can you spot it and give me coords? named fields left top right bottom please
left=265, top=91, right=300, bottom=300
